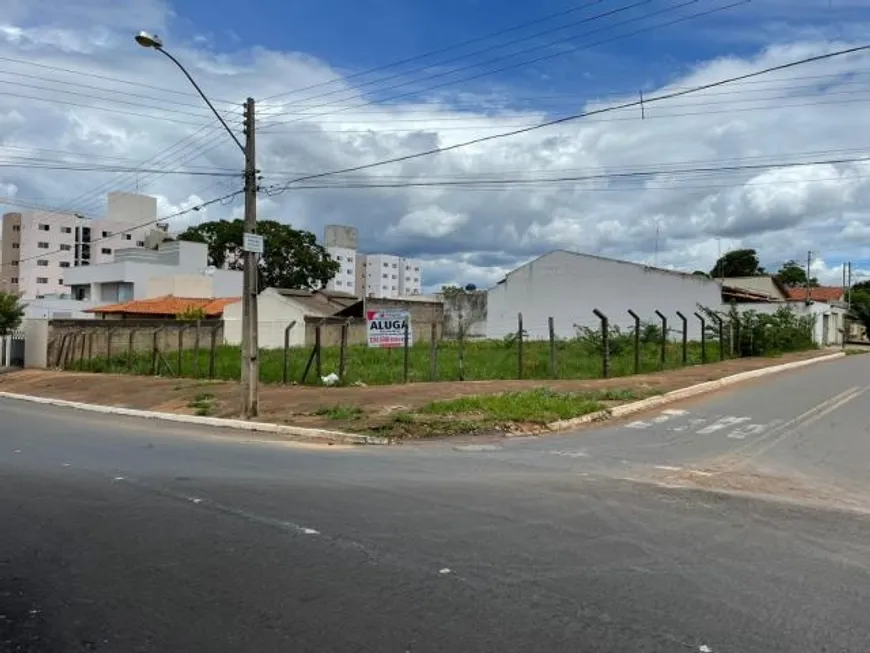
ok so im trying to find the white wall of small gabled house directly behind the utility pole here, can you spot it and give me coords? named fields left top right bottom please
left=224, top=289, right=305, bottom=349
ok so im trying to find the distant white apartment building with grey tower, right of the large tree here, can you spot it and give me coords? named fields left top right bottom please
left=324, top=225, right=423, bottom=297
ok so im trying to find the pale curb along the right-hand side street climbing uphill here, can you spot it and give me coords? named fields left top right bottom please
left=546, top=352, right=846, bottom=431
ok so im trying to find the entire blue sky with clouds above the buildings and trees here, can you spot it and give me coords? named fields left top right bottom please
left=0, top=0, right=870, bottom=290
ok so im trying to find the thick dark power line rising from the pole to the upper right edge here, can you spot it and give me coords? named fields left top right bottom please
left=266, top=45, right=870, bottom=191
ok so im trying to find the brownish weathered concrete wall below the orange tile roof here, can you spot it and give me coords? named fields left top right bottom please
left=45, top=320, right=223, bottom=367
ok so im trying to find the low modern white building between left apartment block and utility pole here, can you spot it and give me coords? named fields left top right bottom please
left=66, top=241, right=242, bottom=304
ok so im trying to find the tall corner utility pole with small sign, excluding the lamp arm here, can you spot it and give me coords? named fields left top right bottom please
left=241, top=98, right=262, bottom=419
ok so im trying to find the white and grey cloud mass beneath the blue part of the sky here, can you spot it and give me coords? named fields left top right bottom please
left=0, top=0, right=870, bottom=286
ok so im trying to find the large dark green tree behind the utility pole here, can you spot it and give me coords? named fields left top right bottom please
left=178, top=219, right=341, bottom=289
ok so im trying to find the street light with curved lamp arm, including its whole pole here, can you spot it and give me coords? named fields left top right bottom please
left=133, top=32, right=262, bottom=419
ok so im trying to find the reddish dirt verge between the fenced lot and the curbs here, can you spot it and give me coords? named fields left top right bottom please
left=0, top=351, right=831, bottom=437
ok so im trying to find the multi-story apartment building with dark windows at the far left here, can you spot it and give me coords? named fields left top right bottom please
left=0, top=192, right=166, bottom=299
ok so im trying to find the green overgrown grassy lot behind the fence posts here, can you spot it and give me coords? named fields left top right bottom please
left=71, top=339, right=732, bottom=385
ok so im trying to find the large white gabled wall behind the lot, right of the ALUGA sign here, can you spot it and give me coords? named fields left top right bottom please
left=486, top=250, right=722, bottom=339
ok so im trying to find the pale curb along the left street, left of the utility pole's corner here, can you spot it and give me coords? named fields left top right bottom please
left=0, top=392, right=389, bottom=445
